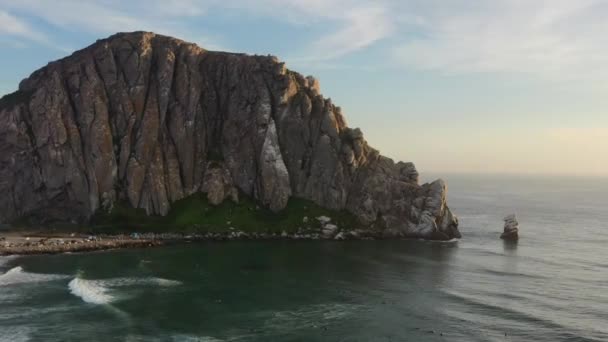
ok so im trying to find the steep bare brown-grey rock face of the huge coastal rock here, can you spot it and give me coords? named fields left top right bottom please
left=0, top=32, right=460, bottom=239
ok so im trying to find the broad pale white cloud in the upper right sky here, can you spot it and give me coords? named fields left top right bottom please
left=393, top=0, right=608, bottom=78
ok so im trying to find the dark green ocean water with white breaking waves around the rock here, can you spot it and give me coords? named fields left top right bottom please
left=0, top=175, right=608, bottom=342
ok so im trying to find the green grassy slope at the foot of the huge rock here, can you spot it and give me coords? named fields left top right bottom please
left=82, top=193, right=360, bottom=234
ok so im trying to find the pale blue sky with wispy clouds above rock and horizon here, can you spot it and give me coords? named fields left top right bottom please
left=0, top=0, right=608, bottom=176
